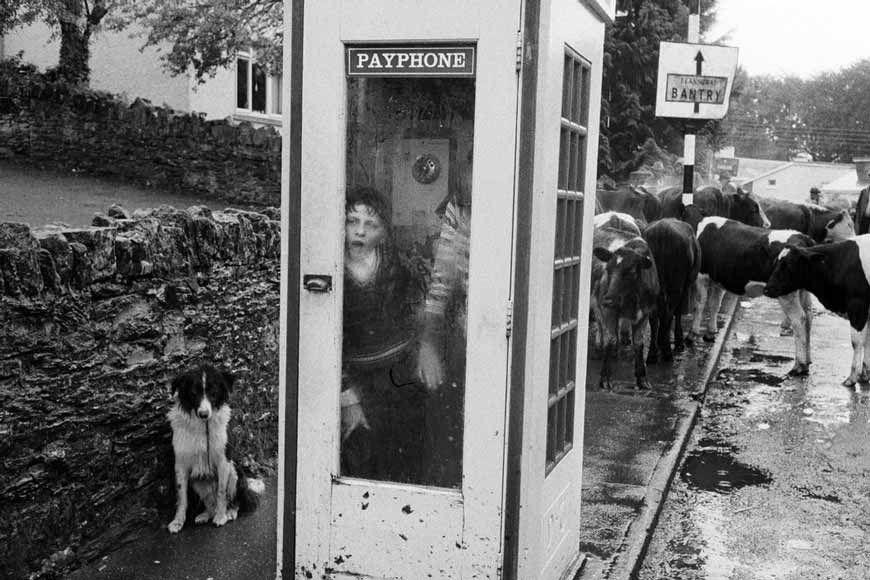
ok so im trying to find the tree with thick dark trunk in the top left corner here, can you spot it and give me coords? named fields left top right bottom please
left=0, top=0, right=117, bottom=85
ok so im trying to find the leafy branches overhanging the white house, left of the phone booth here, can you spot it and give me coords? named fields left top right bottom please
left=112, top=0, right=283, bottom=82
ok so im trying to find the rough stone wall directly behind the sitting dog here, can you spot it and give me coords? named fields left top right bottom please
left=0, top=207, right=280, bottom=578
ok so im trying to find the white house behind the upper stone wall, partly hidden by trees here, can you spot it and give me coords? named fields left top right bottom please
left=0, top=22, right=283, bottom=125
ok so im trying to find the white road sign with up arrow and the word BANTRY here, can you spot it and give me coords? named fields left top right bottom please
left=656, top=42, right=737, bottom=119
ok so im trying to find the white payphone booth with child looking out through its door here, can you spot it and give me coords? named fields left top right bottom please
left=280, top=0, right=613, bottom=580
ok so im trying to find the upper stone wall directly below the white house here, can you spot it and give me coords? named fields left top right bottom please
left=0, top=59, right=281, bottom=206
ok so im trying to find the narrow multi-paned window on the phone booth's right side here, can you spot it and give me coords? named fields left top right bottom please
left=546, top=50, right=590, bottom=473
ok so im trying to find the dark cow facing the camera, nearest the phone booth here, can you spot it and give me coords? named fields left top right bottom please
left=590, top=222, right=659, bottom=390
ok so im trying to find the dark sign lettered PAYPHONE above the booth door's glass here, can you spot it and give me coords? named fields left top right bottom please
left=346, top=45, right=474, bottom=77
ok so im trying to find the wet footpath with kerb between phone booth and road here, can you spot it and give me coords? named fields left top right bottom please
left=579, top=295, right=737, bottom=580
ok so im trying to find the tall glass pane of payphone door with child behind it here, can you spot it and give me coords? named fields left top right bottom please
left=340, top=76, right=475, bottom=487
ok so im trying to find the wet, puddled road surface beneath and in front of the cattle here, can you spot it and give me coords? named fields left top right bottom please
left=638, top=298, right=870, bottom=580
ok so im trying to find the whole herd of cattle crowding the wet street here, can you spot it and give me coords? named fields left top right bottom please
left=590, top=186, right=870, bottom=389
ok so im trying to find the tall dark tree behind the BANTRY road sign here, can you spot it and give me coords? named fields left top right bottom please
left=598, top=0, right=718, bottom=177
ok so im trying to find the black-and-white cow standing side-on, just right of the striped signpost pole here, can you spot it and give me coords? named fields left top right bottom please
left=692, top=217, right=815, bottom=375
